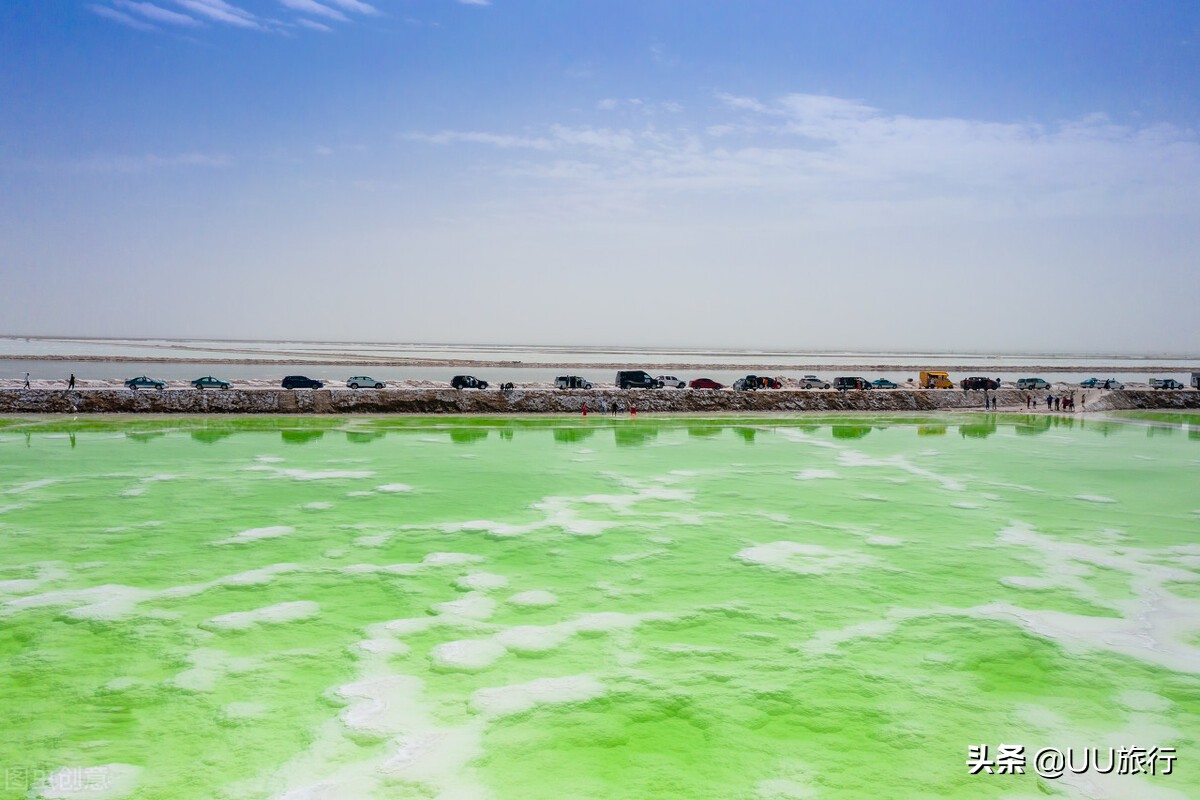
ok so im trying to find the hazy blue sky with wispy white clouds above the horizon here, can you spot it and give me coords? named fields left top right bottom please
left=0, top=0, right=1200, bottom=353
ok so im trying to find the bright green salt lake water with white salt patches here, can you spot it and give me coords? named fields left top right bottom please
left=0, top=414, right=1200, bottom=800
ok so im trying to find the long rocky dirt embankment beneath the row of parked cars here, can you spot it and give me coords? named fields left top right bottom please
left=0, top=387, right=1200, bottom=414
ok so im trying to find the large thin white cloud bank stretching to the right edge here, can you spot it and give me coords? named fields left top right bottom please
left=409, top=94, right=1200, bottom=219
